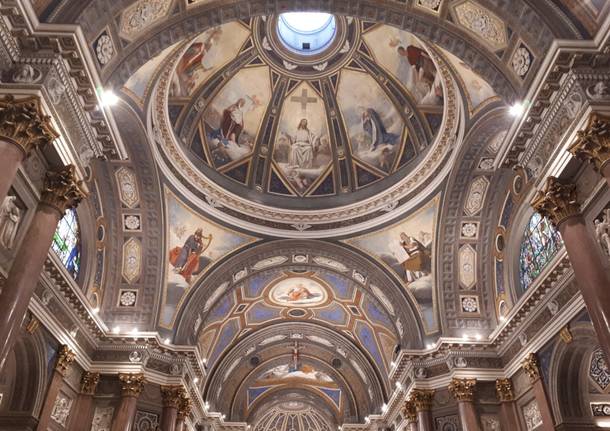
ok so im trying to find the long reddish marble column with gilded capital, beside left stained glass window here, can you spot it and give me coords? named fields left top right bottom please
left=0, top=165, right=84, bottom=369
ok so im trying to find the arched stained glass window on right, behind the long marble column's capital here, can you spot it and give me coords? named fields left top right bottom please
left=519, top=213, right=563, bottom=290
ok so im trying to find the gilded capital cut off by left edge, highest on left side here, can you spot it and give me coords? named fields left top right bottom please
left=0, top=95, right=59, bottom=157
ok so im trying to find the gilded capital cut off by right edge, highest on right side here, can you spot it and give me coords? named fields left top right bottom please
left=568, top=114, right=610, bottom=173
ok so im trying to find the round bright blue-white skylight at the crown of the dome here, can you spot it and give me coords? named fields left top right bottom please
left=277, top=12, right=337, bottom=55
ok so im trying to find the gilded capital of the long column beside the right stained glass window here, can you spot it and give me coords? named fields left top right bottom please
left=532, top=177, right=580, bottom=227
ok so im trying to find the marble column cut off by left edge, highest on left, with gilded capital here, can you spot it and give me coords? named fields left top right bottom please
left=0, top=95, right=59, bottom=202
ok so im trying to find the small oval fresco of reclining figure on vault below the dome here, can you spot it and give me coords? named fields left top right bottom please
left=269, top=277, right=328, bottom=307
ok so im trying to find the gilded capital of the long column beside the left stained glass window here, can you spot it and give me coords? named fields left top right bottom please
left=41, top=165, right=85, bottom=215
